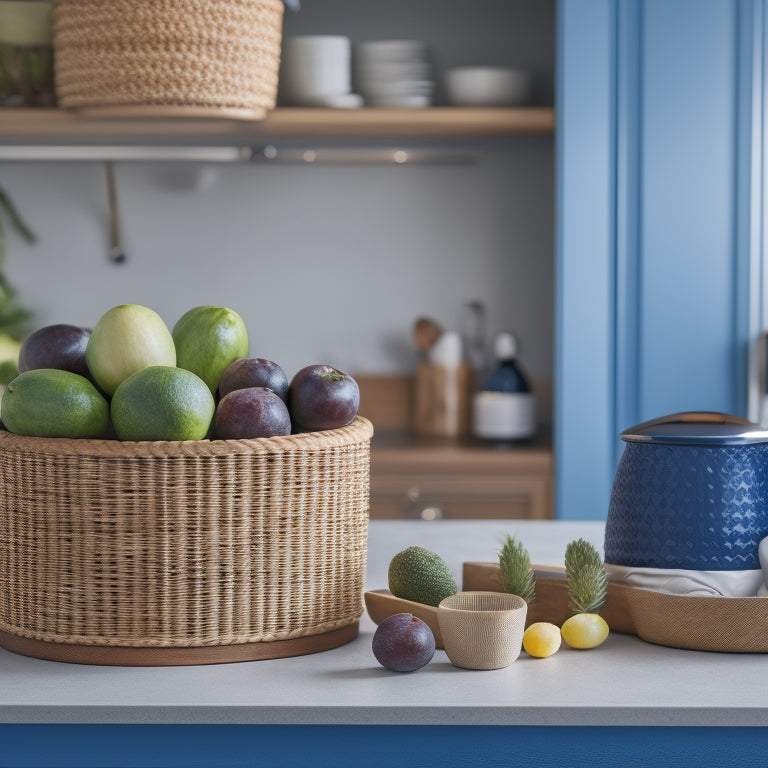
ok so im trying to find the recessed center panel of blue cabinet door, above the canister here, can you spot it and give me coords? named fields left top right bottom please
left=640, top=0, right=745, bottom=420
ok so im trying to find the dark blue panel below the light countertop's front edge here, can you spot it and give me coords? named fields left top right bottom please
left=0, top=725, right=768, bottom=768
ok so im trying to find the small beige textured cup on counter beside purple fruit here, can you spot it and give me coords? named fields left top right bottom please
left=437, top=592, right=528, bottom=669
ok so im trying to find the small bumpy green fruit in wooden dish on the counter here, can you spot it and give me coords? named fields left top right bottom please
left=388, top=547, right=456, bottom=605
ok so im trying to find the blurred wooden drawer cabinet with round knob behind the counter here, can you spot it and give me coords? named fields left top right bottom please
left=371, top=436, right=552, bottom=520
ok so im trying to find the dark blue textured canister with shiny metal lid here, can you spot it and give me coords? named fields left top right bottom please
left=604, top=412, right=768, bottom=571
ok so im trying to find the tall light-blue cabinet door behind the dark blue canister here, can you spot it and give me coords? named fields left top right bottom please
left=555, top=0, right=764, bottom=518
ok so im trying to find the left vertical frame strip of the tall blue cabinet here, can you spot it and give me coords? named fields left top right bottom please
left=554, top=0, right=616, bottom=519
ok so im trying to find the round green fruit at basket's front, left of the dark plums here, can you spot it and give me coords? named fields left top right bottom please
left=111, top=365, right=216, bottom=440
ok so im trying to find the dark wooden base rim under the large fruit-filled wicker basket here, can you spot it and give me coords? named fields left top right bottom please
left=0, top=621, right=359, bottom=667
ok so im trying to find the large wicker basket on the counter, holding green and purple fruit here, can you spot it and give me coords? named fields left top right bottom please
left=0, top=417, right=373, bottom=665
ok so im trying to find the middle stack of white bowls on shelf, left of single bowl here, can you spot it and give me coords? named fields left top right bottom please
left=352, top=40, right=435, bottom=107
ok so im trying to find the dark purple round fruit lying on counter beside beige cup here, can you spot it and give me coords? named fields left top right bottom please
left=371, top=613, right=435, bottom=672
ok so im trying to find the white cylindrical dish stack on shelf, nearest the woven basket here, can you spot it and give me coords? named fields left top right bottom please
left=280, top=35, right=362, bottom=107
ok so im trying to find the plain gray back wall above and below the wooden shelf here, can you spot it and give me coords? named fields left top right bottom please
left=0, top=0, right=554, bottom=402
